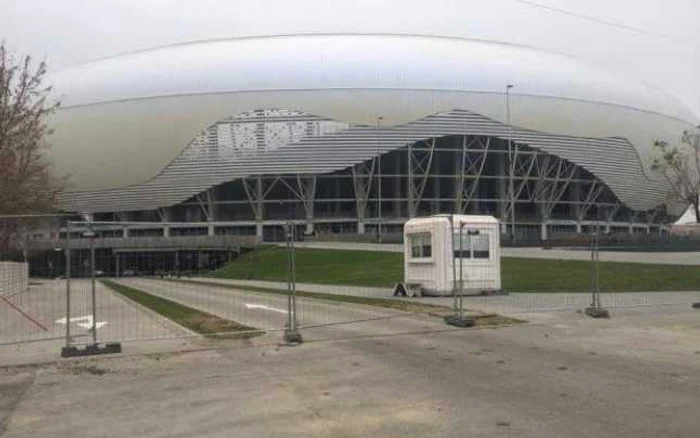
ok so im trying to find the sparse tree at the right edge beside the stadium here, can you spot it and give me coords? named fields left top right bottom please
left=651, top=126, right=700, bottom=223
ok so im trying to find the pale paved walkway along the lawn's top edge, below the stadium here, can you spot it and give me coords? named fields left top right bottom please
left=288, top=242, right=700, bottom=265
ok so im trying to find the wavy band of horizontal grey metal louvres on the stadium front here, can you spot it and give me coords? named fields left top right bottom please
left=61, top=110, right=664, bottom=211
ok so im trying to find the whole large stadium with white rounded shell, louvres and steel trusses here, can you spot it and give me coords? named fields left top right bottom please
left=46, top=35, right=697, bottom=239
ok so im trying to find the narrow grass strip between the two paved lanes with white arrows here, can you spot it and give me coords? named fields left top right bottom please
left=100, top=280, right=262, bottom=338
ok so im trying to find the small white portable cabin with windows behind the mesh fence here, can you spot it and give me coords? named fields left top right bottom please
left=404, top=215, right=501, bottom=295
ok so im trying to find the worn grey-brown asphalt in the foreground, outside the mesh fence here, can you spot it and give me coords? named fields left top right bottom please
left=0, top=306, right=700, bottom=438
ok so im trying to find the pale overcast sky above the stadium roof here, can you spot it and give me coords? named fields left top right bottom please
left=0, top=0, right=700, bottom=120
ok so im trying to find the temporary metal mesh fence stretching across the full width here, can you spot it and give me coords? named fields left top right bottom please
left=0, top=216, right=700, bottom=352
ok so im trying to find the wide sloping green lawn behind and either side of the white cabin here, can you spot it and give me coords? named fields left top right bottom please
left=212, top=247, right=700, bottom=292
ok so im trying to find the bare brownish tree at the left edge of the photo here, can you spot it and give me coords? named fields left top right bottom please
left=0, top=42, right=65, bottom=255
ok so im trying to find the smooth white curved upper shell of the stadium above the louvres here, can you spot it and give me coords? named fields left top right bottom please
left=50, top=34, right=697, bottom=210
